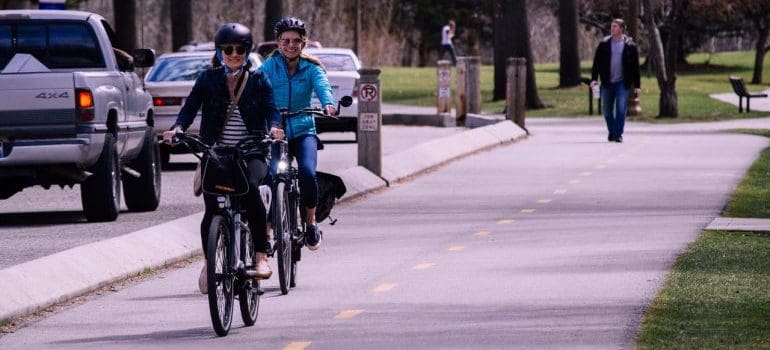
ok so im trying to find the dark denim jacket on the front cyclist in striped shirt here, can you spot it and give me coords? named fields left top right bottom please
left=172, top=67, right=281, bottom=144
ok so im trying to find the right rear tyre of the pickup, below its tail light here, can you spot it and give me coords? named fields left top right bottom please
left=80, top=133, right=120, bottom=221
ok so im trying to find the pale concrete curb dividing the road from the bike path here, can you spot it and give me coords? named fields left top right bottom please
left=0, top=121, right=526, bottom=322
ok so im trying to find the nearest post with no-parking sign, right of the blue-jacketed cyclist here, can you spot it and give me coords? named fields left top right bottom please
left=358, top=68, right=382, bottom=176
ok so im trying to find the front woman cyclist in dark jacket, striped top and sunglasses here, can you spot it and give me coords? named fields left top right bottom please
left=163, top=23, right=284, bottom=293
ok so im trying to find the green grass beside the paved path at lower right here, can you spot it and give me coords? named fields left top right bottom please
left=638, top=130, right=770, bottom=349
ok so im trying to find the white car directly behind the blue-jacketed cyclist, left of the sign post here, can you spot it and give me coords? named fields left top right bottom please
left=305, top=48, right=361, bottom=137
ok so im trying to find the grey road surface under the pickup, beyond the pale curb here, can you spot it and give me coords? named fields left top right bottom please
left=0, top=125, right=464, bottom=269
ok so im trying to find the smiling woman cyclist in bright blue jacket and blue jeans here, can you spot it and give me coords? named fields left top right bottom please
left=260, top=17, right=337, bottom=250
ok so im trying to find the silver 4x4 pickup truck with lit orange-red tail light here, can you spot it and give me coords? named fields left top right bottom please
left=0, top=10, right=161, bottom=221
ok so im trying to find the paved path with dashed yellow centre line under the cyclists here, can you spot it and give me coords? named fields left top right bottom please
left=0, top=119, right=768, bottom=349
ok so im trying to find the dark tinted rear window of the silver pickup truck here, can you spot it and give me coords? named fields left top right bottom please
left=0, top=22, right=105, bottom=69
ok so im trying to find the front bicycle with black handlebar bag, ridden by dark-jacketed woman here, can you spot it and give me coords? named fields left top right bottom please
left=172, top=133, right=269, bottom=336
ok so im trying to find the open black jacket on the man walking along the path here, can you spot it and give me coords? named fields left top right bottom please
left=591, top=36, right=641, bottom=89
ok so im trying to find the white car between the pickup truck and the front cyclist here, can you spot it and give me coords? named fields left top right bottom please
left=144, top=50, right=262, bottom=165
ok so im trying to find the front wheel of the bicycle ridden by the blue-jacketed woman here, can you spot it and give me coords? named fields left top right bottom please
left=272, top=181, right=292, bottom=294
